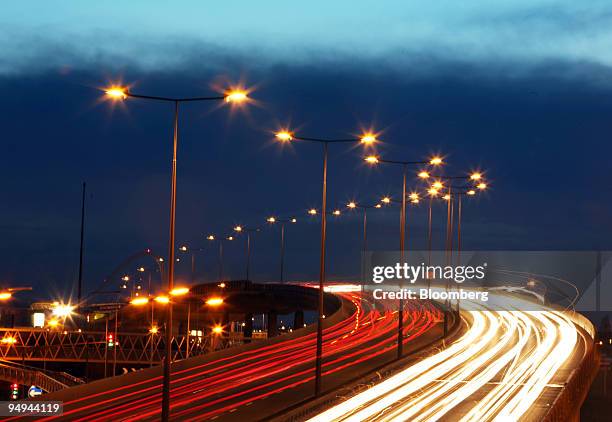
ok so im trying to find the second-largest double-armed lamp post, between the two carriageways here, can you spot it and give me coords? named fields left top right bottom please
left=276, top=130, right=377, bottom=396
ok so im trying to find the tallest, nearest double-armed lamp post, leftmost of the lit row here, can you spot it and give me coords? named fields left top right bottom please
left=106, top=87, right=248, bottom=421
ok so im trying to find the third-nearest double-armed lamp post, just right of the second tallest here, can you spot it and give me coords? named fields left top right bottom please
left=365, top=155, right=442, bottom=359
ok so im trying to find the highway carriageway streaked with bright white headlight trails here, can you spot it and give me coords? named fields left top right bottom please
left=311, top=297, right=592, bottom=422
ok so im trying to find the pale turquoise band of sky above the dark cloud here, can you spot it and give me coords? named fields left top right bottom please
left=0, top=0, right=612, bottom=72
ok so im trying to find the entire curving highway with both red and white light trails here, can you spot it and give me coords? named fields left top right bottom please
left=2, top=286, right=599, bottom=422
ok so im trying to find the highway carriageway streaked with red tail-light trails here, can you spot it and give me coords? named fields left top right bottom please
left=20, top=292, right=440, bottom=421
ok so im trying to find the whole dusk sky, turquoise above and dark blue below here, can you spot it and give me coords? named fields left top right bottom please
left=0, top=0, right=612, bottom=295
